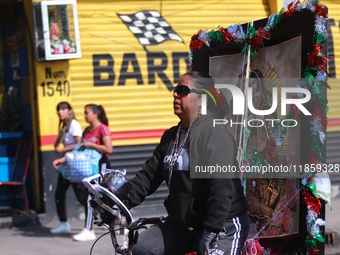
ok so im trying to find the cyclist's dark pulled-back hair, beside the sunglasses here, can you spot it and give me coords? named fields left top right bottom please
left=184, top=71, right=229, bottom=118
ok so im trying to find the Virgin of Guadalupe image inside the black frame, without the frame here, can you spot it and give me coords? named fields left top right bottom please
left=209, top=36, right=302, bottom=238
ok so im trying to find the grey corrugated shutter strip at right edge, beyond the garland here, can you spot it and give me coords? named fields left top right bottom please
left=326, top=132, right=340, bottom=183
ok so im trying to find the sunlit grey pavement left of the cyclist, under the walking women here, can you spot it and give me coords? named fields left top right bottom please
left=0, top=205, right=166, bottom=255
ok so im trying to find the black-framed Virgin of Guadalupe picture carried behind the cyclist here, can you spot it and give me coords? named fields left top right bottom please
left=190, top=5, right=326, bottom=254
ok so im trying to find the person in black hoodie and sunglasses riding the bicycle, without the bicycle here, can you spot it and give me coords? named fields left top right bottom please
left=125, top=72, right=249, bottom=255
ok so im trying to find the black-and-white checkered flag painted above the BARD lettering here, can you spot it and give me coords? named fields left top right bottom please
left=118, top=11, right=183, bottom=46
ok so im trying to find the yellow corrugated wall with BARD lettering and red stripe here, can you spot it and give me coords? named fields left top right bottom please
left=35, top=0, right=268, bottom=214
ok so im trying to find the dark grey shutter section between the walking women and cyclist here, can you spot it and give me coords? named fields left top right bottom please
left=109, top=144, right=168, bottom=204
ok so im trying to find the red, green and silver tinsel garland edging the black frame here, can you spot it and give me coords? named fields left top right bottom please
left=190, top=0, right=328, bottom=255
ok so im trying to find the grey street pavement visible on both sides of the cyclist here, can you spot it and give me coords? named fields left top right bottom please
left=0, top=185, right=340, bottom=255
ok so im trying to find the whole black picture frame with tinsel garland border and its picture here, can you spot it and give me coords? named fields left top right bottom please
left=190, top=1, right=328, bottom=254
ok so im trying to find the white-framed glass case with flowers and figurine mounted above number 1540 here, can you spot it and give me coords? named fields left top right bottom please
left=33, top=0, right=81, bottom=61
